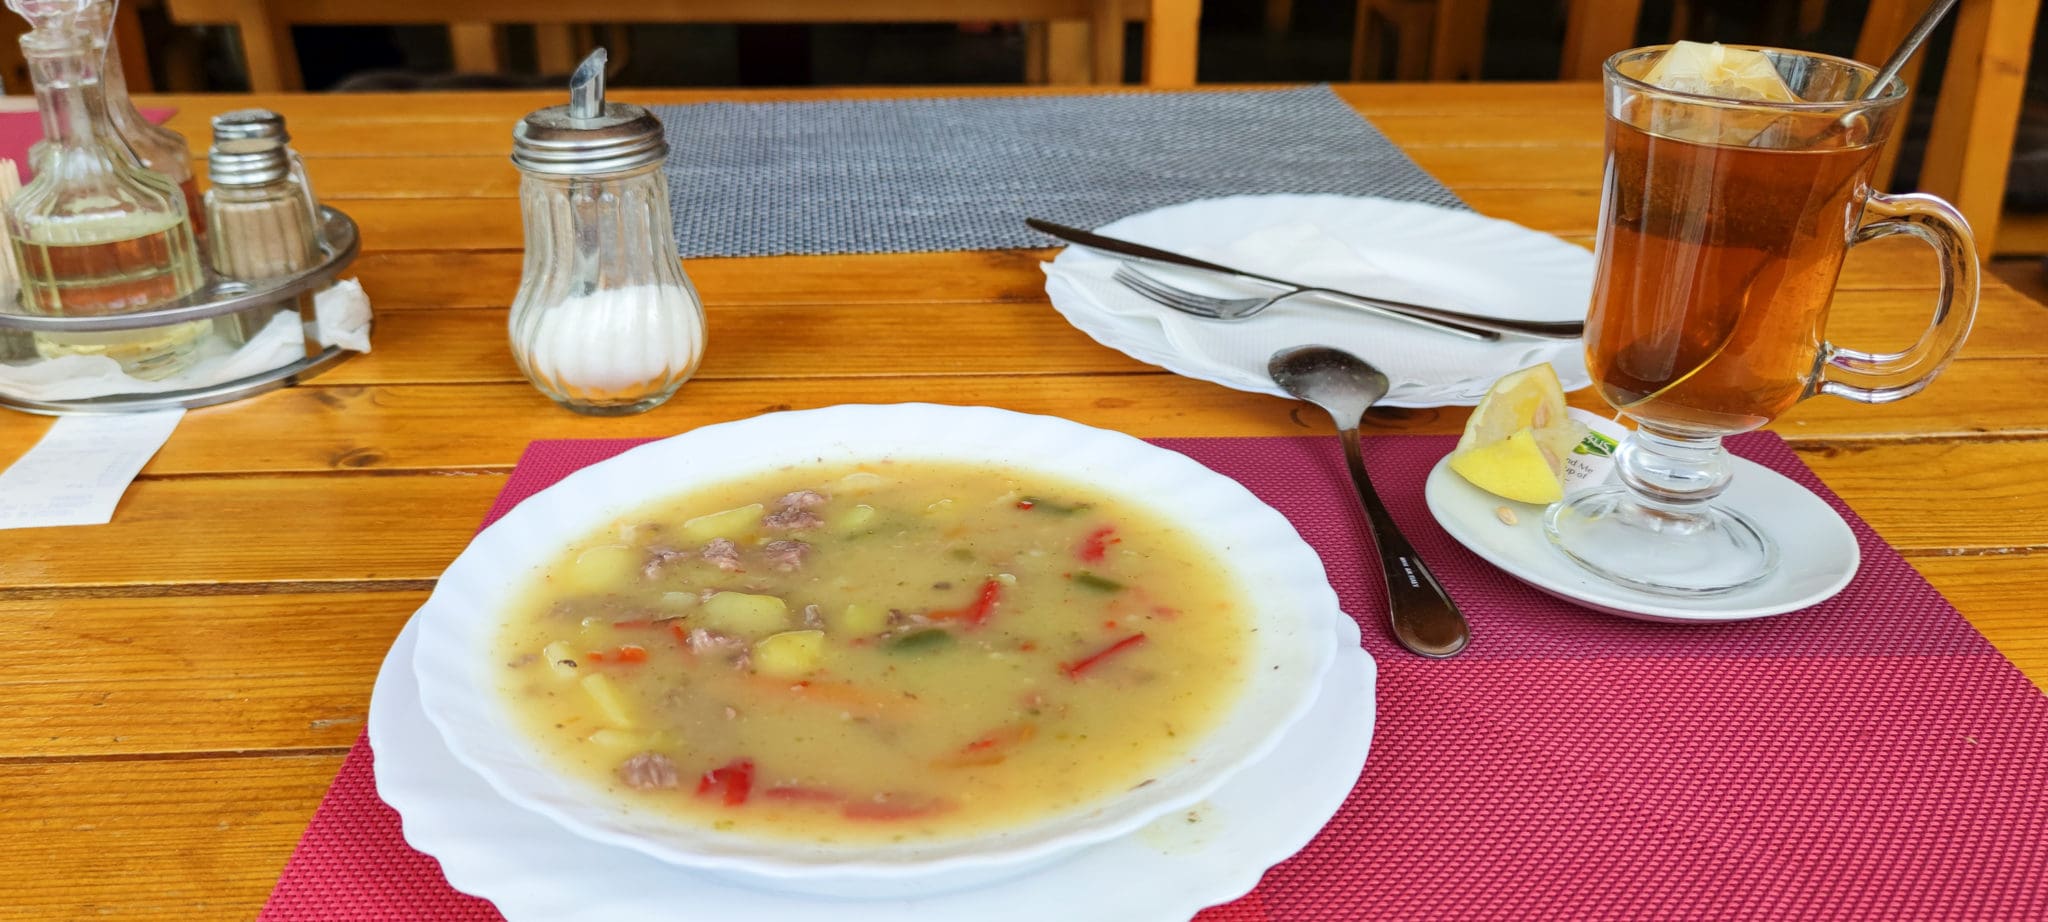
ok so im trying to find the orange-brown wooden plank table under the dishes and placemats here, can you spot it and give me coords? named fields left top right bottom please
left=0, top=84, right=2048, bottom=918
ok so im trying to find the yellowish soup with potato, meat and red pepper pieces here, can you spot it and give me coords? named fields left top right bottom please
left=498, top=461, right=1249, bottom=842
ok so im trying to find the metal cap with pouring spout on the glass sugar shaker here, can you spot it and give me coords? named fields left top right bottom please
left=512, top=47, right=668, bottom=176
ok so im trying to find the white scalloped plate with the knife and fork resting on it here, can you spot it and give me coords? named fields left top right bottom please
left=1044, top=195, right=1593, bottom=408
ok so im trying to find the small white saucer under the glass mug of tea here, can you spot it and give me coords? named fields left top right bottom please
left=1423, top=457, right=1864, bottom=625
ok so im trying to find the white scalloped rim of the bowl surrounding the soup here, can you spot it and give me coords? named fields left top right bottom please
left=414, top=404, right=1339, bottom=895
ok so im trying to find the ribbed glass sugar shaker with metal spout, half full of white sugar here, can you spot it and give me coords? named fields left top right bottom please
left=508, top=49, right=705, bottom=416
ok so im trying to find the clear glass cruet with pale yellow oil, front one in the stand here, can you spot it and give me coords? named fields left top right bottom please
left=6, top=0, right=211, bottom=379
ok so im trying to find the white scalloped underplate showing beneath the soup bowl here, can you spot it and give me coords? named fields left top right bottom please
left=369, top=615, right=1376, bottom=922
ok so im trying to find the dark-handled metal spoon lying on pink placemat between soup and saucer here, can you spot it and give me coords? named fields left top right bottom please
left=1266, top=346, right=1473, bottom=658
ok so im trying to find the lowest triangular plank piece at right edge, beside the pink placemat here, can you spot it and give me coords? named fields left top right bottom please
left=1911, top=553, right=2048, bottom=693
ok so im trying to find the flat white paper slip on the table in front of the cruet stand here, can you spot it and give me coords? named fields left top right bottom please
left=0, top=410, right=184, bottom=529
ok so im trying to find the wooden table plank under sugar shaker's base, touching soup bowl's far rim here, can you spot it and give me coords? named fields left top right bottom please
left=0, top=359, right=2048, bottom=479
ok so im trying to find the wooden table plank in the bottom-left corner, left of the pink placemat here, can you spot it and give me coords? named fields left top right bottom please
left=0, top=754, right=342, bottom=920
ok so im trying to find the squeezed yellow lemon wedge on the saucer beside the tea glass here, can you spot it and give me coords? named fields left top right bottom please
left=1450, top=365, right=1585, bottom=504
